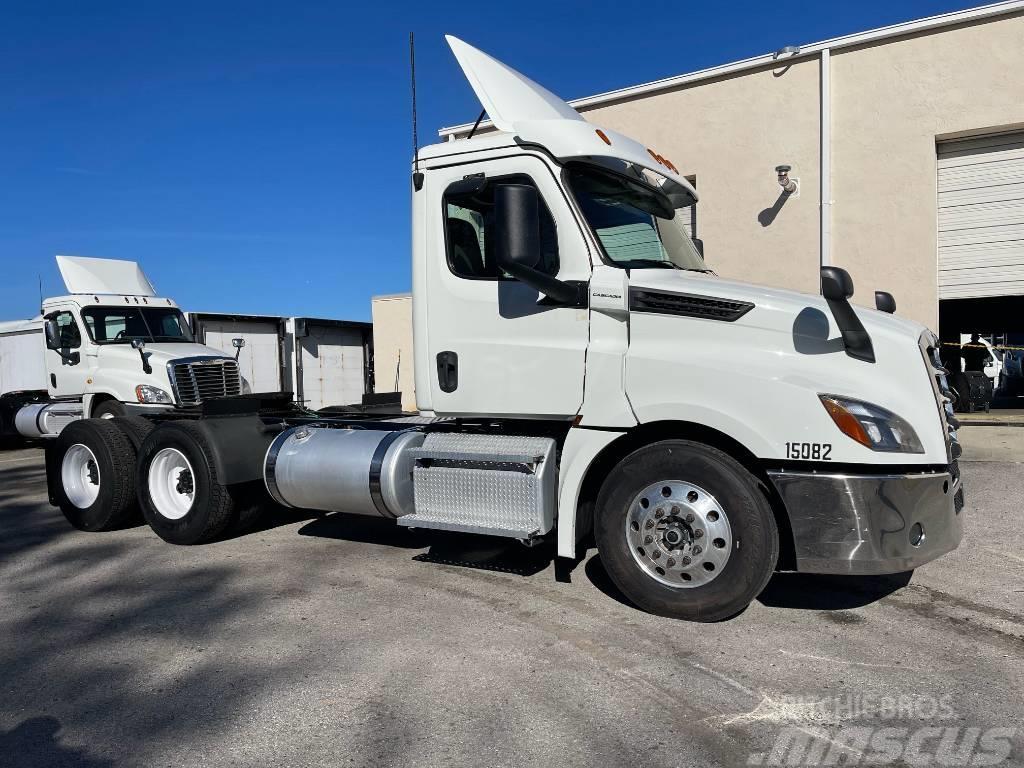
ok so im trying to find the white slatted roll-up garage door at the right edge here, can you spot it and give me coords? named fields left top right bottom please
left=938, top=133, right=1024, bottom=299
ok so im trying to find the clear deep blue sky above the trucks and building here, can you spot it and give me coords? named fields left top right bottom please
left=0, top=0, right=970, bottom=321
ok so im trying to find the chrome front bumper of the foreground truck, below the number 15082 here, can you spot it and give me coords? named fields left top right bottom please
left=768, top=469, right=963, bottom=574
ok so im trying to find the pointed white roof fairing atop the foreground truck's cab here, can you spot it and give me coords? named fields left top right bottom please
left=445, top=35, right=697, bottom=204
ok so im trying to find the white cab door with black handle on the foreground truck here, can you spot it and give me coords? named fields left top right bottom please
left=418, top=155, right=591, bottom=418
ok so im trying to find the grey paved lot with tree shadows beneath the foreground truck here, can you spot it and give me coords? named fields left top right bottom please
left=0, top=448, right=1024, bottom=767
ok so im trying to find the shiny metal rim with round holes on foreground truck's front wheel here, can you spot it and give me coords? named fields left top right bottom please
left=625, top=480, right=733, bottom=589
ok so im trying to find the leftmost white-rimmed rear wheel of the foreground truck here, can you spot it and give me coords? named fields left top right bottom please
left=48, top=420, right=137, bottom=530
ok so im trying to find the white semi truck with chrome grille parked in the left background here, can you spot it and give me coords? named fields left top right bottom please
left=0, top=256, right=248, bottom=437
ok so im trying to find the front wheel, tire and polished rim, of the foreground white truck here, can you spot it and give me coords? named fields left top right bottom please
left=595, top=440, right=778, bottom=622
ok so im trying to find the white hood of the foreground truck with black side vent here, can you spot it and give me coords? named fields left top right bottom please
left=626, top=269, right=947, bottom=465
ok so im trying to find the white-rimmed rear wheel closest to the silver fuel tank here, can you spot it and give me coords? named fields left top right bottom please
left=136, top=421, right=237, bottom=545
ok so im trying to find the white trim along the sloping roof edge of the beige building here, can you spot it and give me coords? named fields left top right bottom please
left=437, top=0, right=1024, bottom=138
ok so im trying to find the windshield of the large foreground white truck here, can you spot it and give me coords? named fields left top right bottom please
left=566, top=165, right=711, bottom=272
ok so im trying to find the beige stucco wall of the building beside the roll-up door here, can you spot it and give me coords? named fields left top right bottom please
left=585, top=9, right=1024, bottom=328
